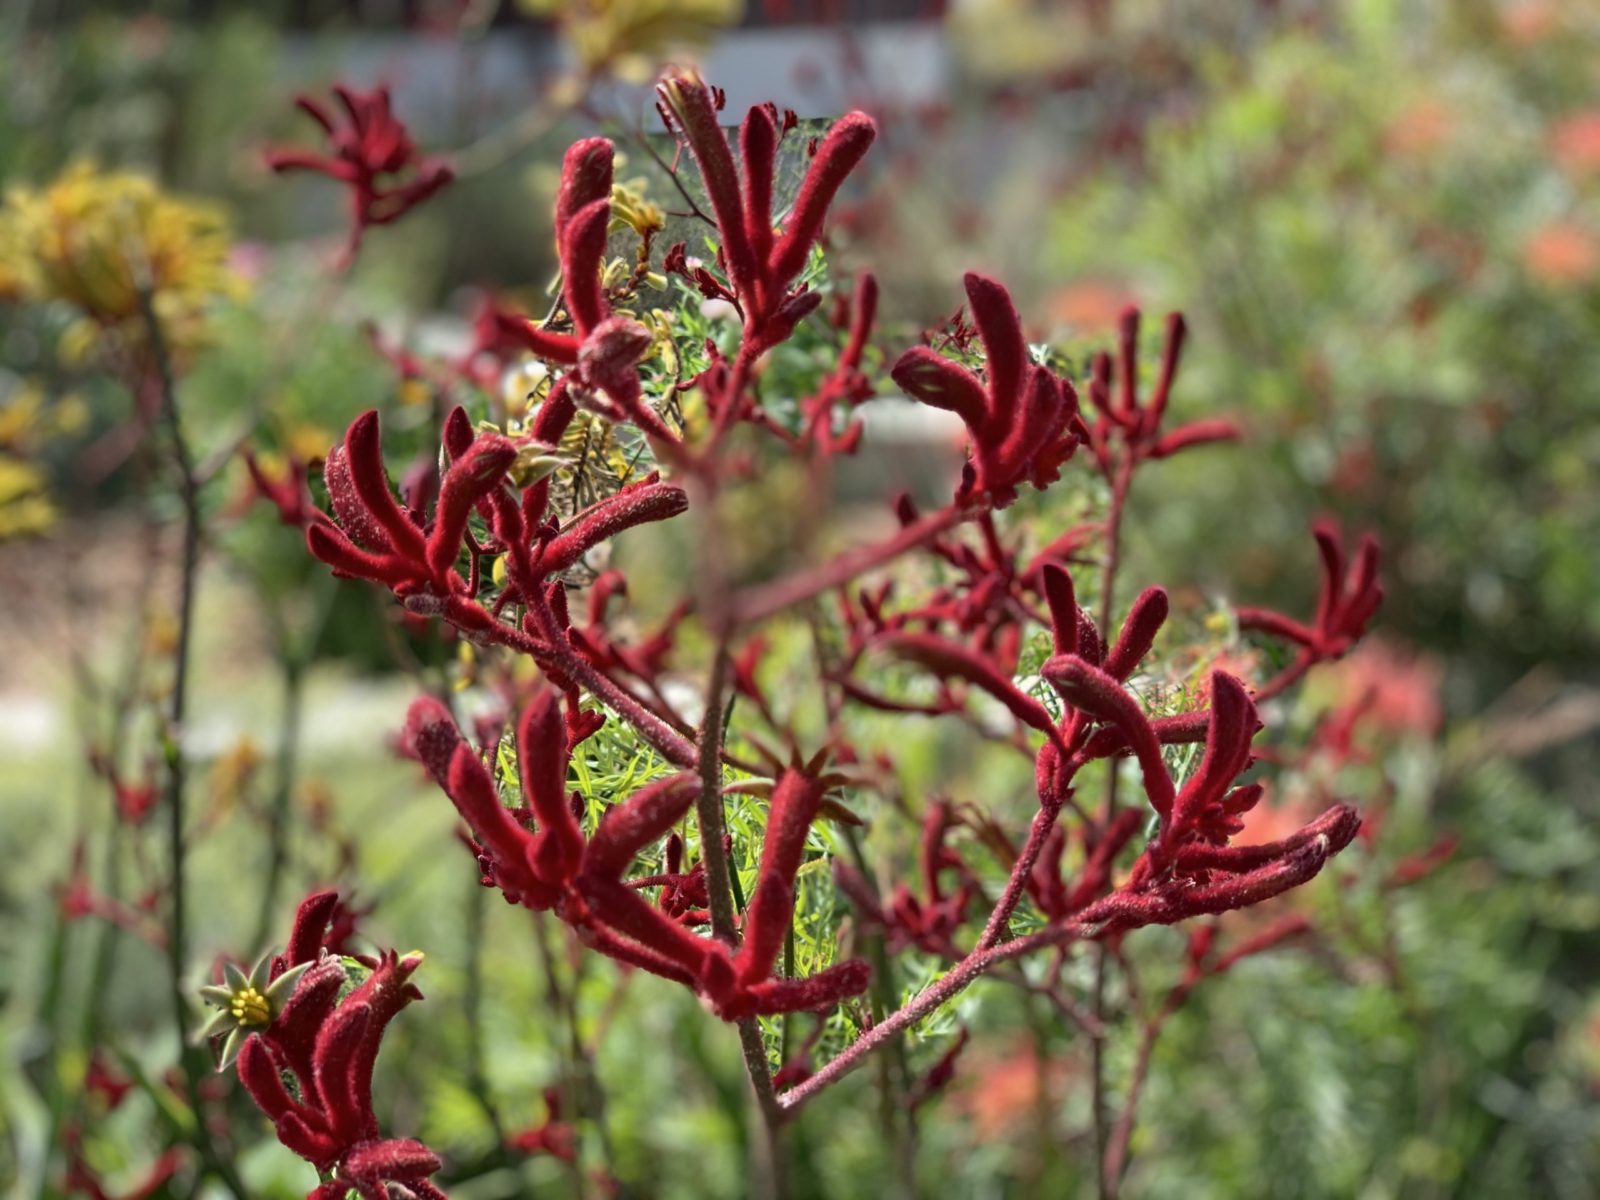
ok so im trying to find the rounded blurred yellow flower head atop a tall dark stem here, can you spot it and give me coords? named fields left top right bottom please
left=0, top=162, right=243, bottom=352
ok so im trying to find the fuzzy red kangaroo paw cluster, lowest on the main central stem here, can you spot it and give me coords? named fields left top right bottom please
left=406, top=691, right=869, bottom=1021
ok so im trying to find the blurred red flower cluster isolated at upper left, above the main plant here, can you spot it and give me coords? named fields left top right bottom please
left=267, top=85, right=454, bottom=261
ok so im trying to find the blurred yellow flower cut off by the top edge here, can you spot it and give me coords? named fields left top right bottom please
left=522, top=0, right=744, bottom=83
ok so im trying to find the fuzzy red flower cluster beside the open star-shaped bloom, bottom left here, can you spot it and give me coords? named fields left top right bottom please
left=222, top=891, right=445, bottom=1200
